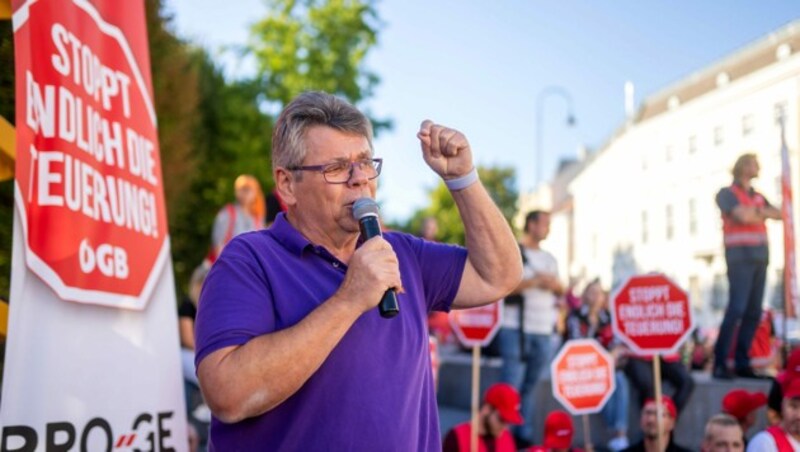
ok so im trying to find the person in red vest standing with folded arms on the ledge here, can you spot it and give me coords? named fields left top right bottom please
left=713, top=154, right=781, bottom=380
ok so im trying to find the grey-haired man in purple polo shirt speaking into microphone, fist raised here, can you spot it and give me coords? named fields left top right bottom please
left=196, top=92, right=522, bottom=452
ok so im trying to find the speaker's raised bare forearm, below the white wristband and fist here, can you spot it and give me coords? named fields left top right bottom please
left=452, top=183, right=522, bottom=304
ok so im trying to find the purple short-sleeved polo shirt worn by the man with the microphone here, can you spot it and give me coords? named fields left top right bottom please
left=195, top=214, right=467, bottom=452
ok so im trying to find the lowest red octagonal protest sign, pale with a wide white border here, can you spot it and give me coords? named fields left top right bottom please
left=550, top=339, right=616, bottom=415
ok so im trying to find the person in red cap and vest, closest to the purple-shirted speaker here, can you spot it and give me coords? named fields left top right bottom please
left=442, top=383, right=523, bottom=452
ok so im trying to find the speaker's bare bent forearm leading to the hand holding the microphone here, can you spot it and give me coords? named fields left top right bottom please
left=198, top=295, right=360, bottom=422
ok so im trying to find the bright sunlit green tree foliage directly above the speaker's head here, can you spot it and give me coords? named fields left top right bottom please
left=248, top=0, right=391, bottom=133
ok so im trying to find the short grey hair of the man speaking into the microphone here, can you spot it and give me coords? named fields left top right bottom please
left=272, top=91, right=372, bottom=172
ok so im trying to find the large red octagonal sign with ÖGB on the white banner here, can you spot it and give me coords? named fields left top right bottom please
left=14, top=0, right=169, bottom=309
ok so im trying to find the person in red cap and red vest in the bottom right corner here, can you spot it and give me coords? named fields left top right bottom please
left=747, top=378, right=800, bottom=452
